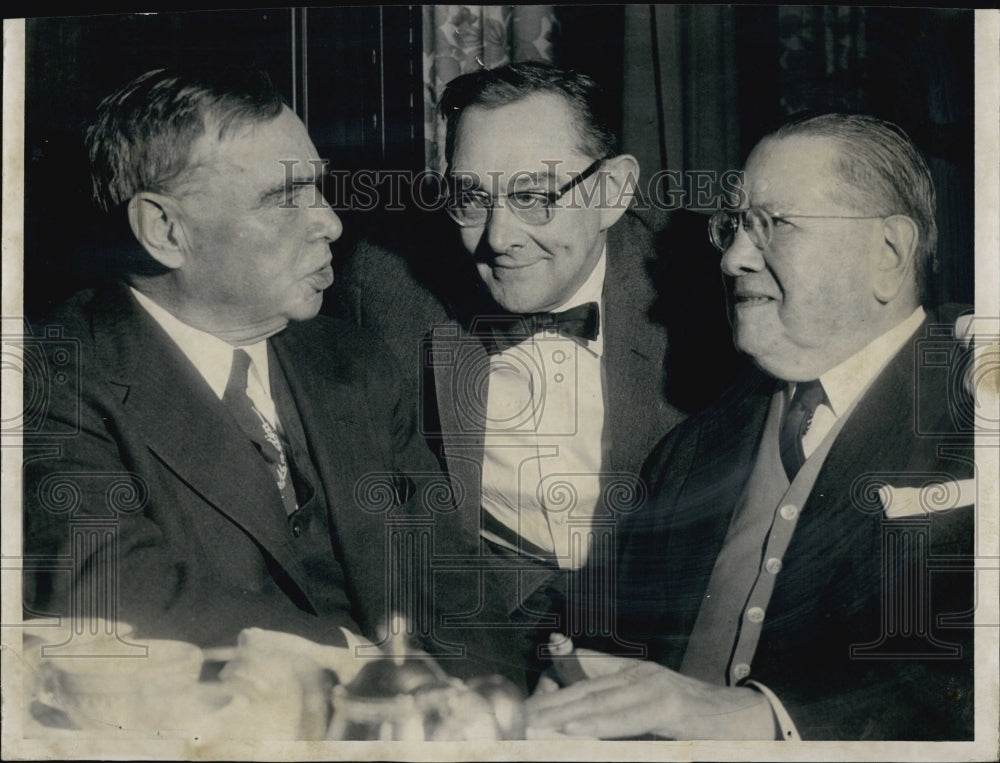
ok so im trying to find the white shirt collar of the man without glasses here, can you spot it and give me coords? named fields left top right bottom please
left=129, top=286, right=271, bottom=400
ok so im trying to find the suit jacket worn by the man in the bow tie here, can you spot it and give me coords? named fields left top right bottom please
left=341, top=213, right=683, bottom=564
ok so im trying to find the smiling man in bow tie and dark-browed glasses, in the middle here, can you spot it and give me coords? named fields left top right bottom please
left=343, top=62, right=682, bottom=664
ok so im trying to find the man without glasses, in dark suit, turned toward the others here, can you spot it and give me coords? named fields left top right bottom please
left=24, top=70, right=480, bottom=654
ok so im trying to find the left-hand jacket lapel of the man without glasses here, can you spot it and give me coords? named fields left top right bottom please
left=94, top=288, right=316, bottom=608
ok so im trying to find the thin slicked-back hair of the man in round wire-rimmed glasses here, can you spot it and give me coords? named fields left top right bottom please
left=769, top=114, right=938, bottom=295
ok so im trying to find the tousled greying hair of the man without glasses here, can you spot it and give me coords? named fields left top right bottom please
left=86, top=68, right=284, bottom=211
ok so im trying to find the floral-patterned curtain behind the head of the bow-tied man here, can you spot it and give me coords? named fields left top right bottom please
left=423, top=5, right=558, bottom=172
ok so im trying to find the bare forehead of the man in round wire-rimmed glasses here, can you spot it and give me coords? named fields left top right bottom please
left=741, top=135, right=849, bottom=212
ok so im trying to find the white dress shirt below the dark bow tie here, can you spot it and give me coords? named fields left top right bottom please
left=482, top=251, right=607, bottom=569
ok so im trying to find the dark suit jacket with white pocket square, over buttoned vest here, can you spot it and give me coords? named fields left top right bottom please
left=618, top=310, right=973, bottom=740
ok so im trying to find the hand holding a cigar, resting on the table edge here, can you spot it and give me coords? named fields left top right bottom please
left=526, top=649, right=775, bottom=739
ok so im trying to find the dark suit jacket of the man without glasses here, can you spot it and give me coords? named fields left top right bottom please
left=24, top=285, right=476, bottom=646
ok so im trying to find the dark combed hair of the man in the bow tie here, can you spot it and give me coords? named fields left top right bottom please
left=438, top=61, right=618, bottom=166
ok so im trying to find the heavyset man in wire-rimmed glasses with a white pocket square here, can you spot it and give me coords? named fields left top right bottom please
left=533, top=114, right=975, bottom=740
